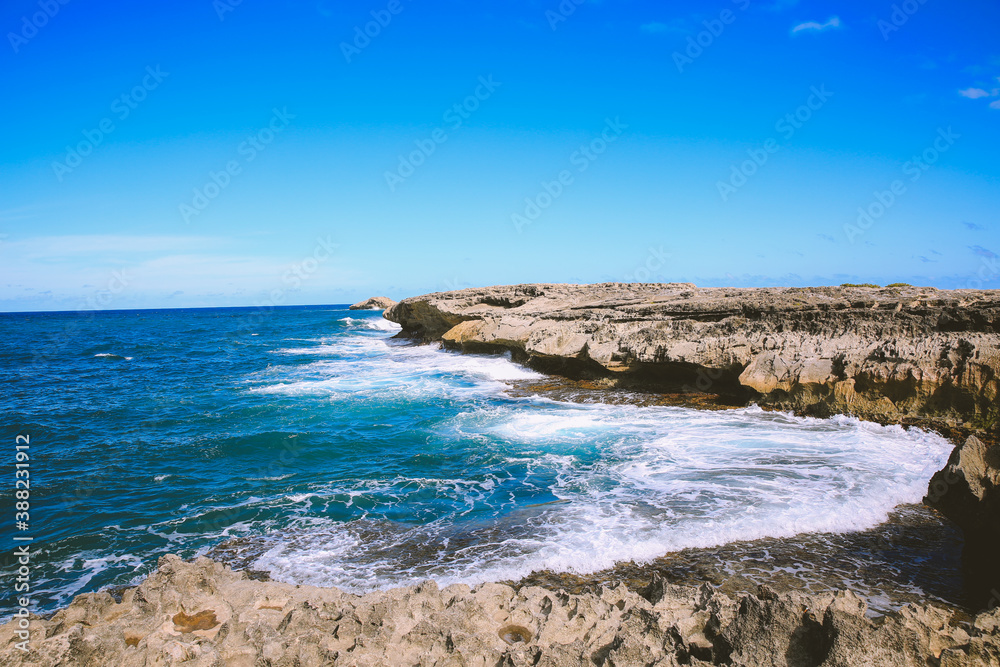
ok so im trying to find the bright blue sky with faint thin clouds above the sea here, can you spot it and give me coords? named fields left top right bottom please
left=0, top=0, right=1000, bottom=311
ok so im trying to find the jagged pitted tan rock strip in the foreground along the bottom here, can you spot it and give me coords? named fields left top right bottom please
left=0, top=556, right=1000, bottom=667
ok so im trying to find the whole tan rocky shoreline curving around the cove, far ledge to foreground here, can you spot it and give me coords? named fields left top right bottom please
left=0, top=283, right=1000, bottom=667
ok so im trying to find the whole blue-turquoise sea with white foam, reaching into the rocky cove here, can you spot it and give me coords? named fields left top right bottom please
left=0, top=306, right=951, bottom=611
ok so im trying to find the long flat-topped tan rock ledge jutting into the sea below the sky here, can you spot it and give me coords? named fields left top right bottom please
left=384, top=283, right=1000, bottom=430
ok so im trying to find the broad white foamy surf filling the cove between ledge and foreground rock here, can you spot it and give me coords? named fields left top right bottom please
left=255, top=402, right=951, bottom=592
